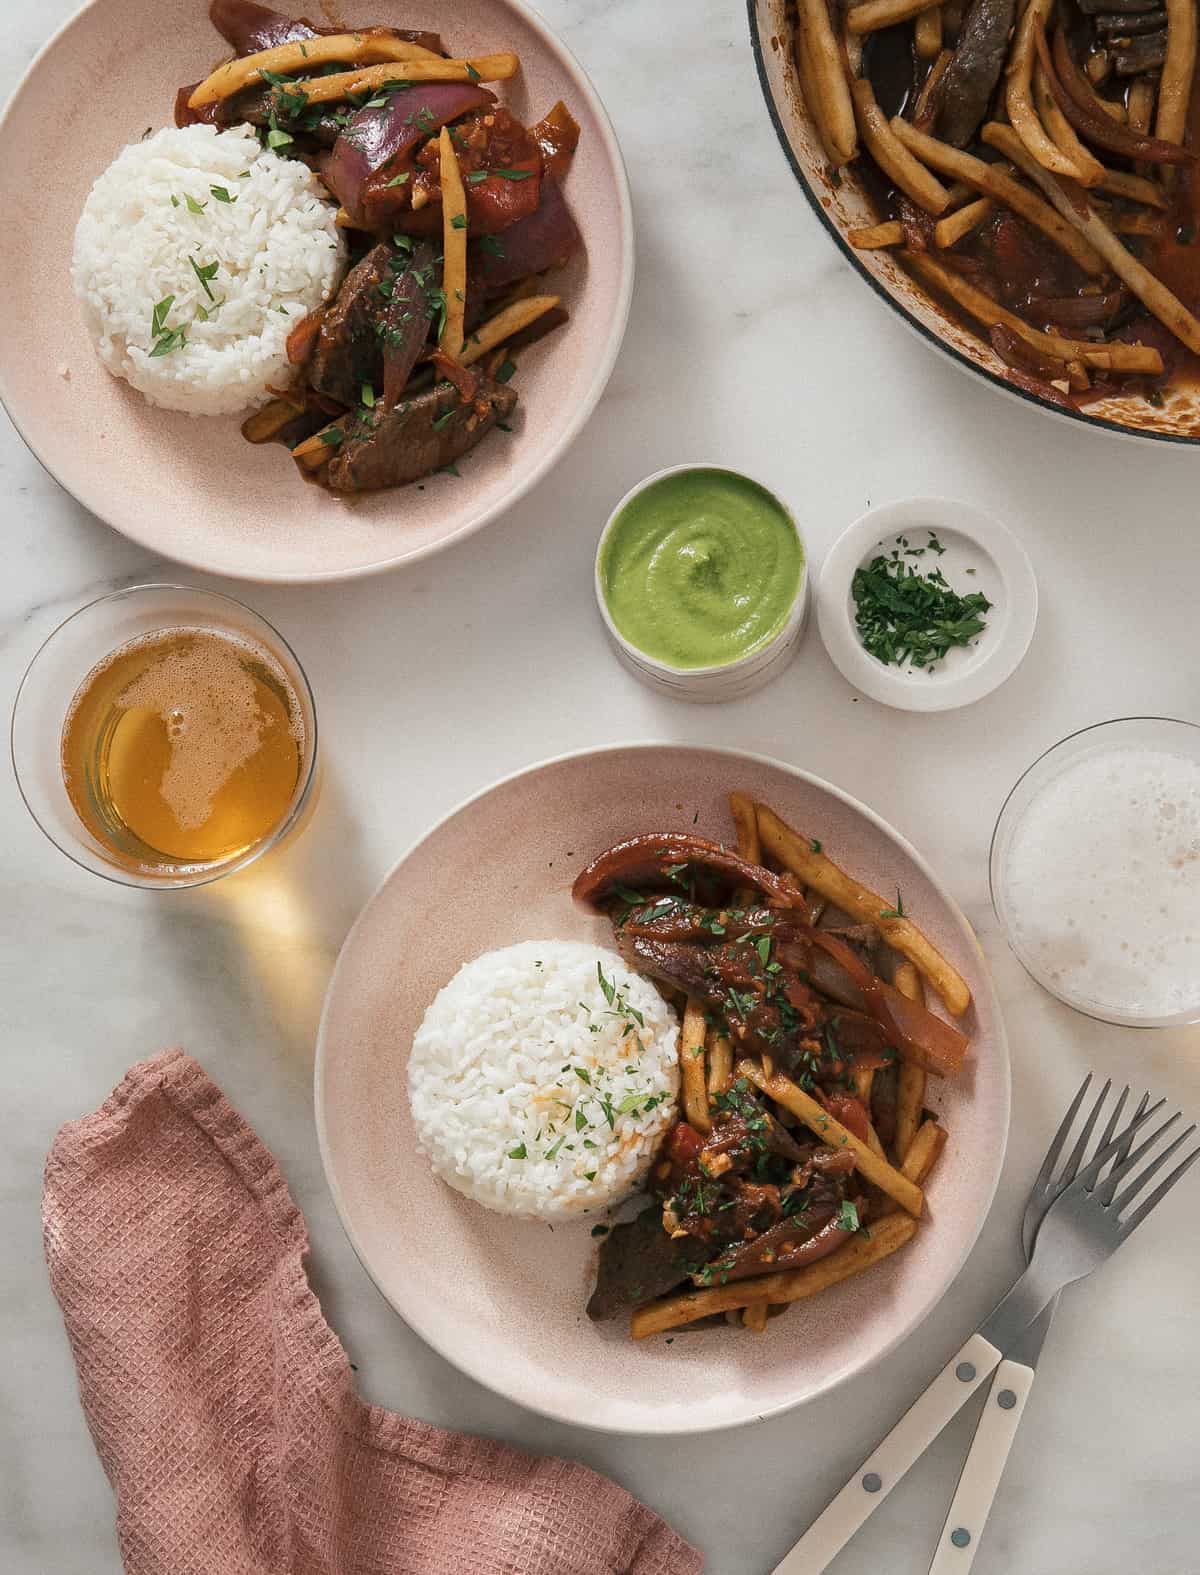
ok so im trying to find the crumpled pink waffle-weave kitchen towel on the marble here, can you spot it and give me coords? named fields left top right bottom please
left=43, top=1051, right=704, bottom=1575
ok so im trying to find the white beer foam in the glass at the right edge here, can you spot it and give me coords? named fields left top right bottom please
left=1003, top=748, right=1200, bottom=1017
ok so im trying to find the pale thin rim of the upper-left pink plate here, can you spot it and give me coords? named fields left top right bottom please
left=0, top=0, right=636, bottom=584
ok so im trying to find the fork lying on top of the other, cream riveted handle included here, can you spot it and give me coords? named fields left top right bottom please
left=773, top=1076, right=1200, bottom=1575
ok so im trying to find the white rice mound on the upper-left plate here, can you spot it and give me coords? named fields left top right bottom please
left=71, top=126, right=345, bottom=416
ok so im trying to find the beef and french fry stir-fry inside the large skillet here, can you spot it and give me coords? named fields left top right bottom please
left=794, top=0, right=1200, bottom=406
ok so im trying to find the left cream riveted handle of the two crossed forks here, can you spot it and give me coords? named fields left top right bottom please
left=773, top=1334, right=1000, bottom=1575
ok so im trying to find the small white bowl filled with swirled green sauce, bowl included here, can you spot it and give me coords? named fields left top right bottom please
left=595, top=465, right=808, bottom=701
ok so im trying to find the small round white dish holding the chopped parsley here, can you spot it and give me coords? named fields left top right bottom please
left=817, top=498, right=1038, bottom=710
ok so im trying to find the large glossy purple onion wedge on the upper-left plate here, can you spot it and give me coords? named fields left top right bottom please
left=324, top=83, right=496, bottom=224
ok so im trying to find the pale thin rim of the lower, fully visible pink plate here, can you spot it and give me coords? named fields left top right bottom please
left=313, top=739, right=1013, bottom=1438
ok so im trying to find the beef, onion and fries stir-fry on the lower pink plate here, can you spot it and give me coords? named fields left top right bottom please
left=573, top=794, right=970, bottom=1337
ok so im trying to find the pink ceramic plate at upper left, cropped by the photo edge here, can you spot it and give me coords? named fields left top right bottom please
left=0, top=0, right=633, bottom=581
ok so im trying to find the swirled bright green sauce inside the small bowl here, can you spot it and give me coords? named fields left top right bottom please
left=600, top=469, right=805, bottom=668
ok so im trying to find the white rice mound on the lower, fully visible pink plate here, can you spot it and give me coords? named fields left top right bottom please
left=408, top=940, right=679, bottom=1219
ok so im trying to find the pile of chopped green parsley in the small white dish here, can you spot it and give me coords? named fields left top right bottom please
left=850, top=532, right=992, bottom=671
